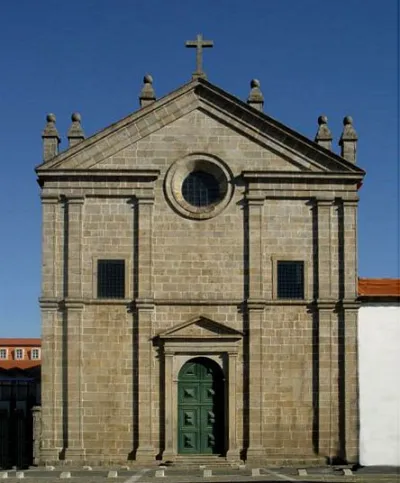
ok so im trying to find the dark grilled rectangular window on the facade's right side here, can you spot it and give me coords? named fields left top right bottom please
left=277, top=260, right=304, bottom=299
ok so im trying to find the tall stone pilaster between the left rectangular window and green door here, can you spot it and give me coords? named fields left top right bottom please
left=136, top=195, right=156, bottom=461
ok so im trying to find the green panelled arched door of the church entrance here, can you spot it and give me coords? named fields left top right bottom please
left=178, top=357, right=224, bottom=454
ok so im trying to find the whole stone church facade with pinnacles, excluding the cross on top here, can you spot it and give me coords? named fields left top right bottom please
left=36, top=44, right=364, bottom=463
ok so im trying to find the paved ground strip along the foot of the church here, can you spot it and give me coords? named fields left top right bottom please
left=0, top=466, right=400, bottom=483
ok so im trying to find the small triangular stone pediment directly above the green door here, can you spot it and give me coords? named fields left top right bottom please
left=158, top=315, right=243, bottom=340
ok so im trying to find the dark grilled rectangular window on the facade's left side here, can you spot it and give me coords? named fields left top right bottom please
left=97, top=260, right=125, bottom=299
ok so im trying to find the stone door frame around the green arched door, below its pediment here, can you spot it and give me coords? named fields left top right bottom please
left=163, top=336, right=241, bottom=461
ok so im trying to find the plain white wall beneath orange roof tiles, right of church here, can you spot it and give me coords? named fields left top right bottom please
left=358, top=303, right=400, bottom=466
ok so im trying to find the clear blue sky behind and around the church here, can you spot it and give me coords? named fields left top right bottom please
left=0, top=0, right=399, bottom=337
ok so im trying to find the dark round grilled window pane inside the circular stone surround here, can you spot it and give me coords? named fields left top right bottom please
left=182, top=171, right=220, bottom=206
